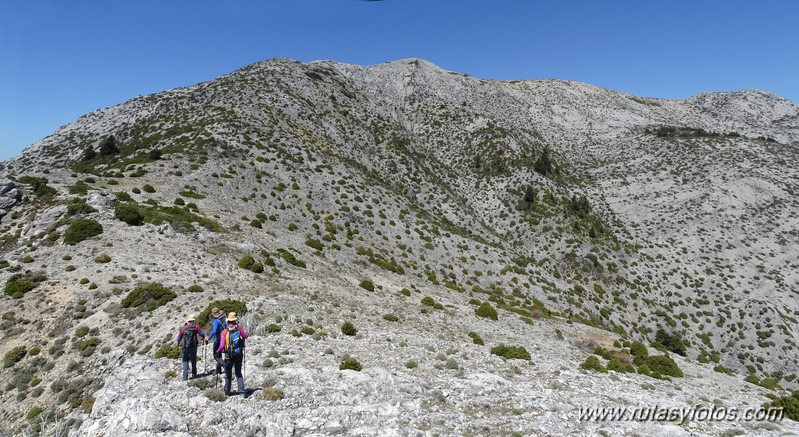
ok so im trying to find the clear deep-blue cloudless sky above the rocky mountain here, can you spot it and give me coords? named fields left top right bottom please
left=0, top=0, right=799, bottom=160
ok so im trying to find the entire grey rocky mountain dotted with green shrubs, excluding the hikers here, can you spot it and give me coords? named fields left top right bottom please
left=0, top=59, right=799, bottom=435
